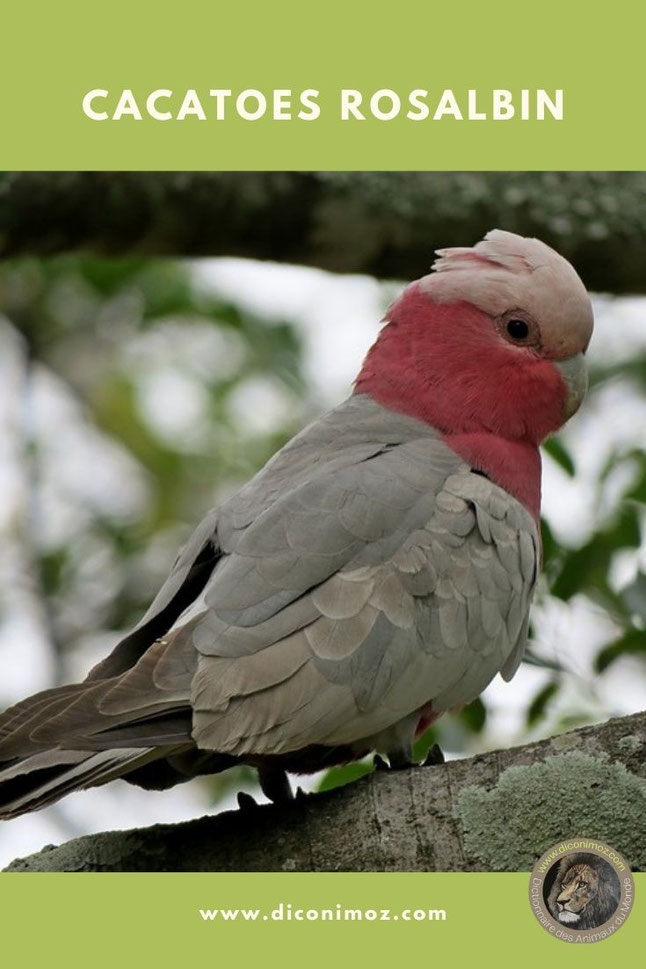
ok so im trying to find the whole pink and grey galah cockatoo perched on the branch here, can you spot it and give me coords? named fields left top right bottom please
left=0, top=230, right=593, bottom=818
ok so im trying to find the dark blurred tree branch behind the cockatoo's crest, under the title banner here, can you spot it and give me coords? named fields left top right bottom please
left=0, top=172, right=646, bottom=293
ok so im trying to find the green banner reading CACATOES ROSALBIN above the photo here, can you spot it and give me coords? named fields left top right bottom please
left=0, top=0, right=646, bottom=170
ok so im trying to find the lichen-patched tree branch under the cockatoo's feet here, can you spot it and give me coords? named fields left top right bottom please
left=7, top=713, right=646, bottom=871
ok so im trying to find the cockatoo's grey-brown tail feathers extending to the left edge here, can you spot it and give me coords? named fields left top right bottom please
left=0, top=624, right=197, bottom=820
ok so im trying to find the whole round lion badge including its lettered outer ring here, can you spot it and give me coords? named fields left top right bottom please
left=529, top=838, right=635, bottom=942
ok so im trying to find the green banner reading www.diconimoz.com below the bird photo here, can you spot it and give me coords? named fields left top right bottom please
left=0, top=873, right=646, bottom=969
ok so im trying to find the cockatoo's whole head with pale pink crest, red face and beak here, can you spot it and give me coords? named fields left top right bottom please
left=357, top=230, right=592, bottom=445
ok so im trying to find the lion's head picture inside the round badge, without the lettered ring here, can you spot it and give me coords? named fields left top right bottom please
left=547, top=852, right=621, bottom=929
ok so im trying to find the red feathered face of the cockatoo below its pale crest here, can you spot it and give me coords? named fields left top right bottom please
left=357, top=284, right=589, bottom=444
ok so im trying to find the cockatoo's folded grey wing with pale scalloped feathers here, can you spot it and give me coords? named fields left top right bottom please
left=192, top=437, right=538, bottom=753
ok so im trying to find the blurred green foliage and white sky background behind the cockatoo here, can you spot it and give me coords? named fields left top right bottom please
left=0, top=180, right=646, bottom=856
